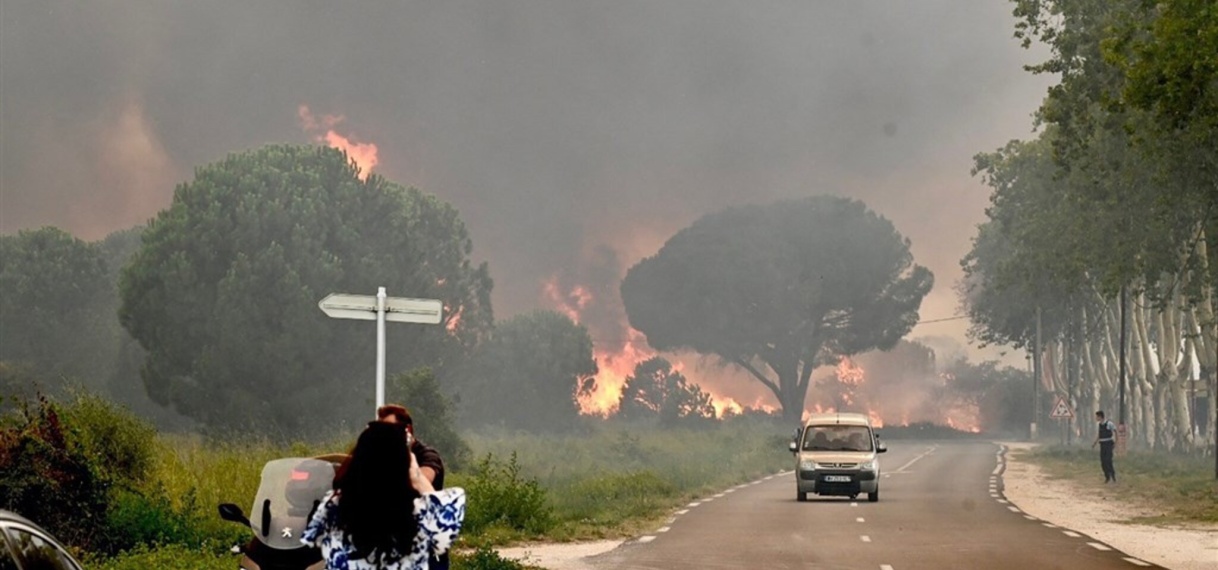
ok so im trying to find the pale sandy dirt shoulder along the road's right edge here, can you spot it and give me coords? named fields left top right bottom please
left=1002, top=442, right=1218, bottom=570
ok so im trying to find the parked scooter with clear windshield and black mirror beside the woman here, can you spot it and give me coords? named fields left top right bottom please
left=219, top=454, right=346, bottom=570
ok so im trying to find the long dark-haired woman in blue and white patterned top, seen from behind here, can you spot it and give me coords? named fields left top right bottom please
left=301, top=421, right=465, bottom=570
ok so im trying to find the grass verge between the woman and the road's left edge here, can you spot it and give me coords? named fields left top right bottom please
left=453, top=419, right=792, bottom=543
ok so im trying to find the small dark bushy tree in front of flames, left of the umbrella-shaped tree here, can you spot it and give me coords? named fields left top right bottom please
left=618, top=357, right=715, bottom=426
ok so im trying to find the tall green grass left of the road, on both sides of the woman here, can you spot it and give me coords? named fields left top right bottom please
left=88, top=419, right=790, bottom=570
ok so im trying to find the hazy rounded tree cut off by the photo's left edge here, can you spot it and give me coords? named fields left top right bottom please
left=0, top=227, right=118, bottom=390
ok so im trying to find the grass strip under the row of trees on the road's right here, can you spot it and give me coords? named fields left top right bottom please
left=1026, top=446, right=1218, bottom=524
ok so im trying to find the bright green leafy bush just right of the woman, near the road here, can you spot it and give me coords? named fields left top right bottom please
left=454, top=453, right=554, bottom=535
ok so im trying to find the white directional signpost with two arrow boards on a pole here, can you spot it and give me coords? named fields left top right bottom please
left=317, top=287, right=445, bottom=408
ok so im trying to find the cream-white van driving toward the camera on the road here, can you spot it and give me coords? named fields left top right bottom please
left=790, top=414, right=888, bottom=503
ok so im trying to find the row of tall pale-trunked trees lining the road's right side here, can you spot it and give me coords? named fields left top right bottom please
left=960, top=0, right=1218, bottom=449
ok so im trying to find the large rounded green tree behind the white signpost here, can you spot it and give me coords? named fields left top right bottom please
left=119, top=145, right=492, bottom=431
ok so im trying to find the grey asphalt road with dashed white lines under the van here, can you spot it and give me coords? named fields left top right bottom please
left=588, top=441, right=1161, bottom=570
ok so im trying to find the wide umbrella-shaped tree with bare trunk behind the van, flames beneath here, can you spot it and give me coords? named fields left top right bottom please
left=621, top=196, right=933, bottom=420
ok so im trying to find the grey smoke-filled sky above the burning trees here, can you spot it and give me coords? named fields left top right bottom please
left=0, top=0, right=1046, bottom=377
